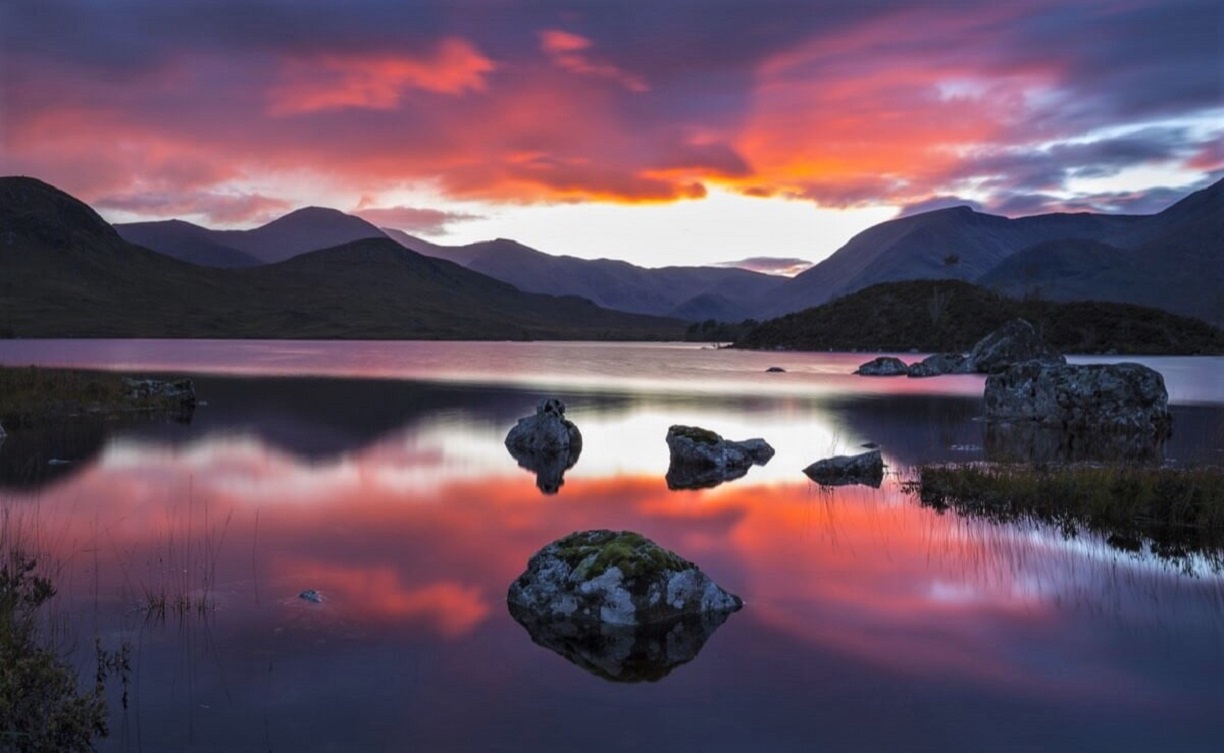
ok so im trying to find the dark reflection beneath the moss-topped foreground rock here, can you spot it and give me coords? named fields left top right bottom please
left=509, top=604, right=730, bottom=682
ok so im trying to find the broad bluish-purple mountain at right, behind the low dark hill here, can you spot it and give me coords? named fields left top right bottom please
left=754, top=181, right=1224, bottom=321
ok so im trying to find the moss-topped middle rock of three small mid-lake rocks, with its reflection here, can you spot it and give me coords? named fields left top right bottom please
left=667, top=425, right=774, bottom=489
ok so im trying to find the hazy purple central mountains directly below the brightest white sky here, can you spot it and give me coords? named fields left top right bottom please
left=392, top=233, right=787, bottom=321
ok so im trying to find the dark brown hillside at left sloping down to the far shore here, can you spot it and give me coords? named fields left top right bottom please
left=0, top=178, right=683, bottom=339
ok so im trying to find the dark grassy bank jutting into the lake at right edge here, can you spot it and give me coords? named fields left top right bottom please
left=906, top=463, right=1224, bottom=569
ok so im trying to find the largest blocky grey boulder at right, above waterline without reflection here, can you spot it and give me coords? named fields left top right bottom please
left=984, top=361, right=1171, bottom=436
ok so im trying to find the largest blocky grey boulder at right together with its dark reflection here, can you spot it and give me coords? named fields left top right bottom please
left=984, top=361, right=1173, bottom=460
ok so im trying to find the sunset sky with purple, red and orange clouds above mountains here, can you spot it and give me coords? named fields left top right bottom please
left=0, top=0, right=1224, bottom=272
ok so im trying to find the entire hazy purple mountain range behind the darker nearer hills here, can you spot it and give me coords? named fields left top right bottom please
left=116, top=181, right=1224, bottom=322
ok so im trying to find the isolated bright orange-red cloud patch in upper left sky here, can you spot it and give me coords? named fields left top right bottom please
left=268, top=38, right=496, bottom=115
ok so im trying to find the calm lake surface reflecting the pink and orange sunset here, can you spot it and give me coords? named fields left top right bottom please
left=0, top=340, right=1224, bottom=753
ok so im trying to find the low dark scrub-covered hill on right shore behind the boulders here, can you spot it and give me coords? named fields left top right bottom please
left=734, top=279, right=1224, bottom=355
